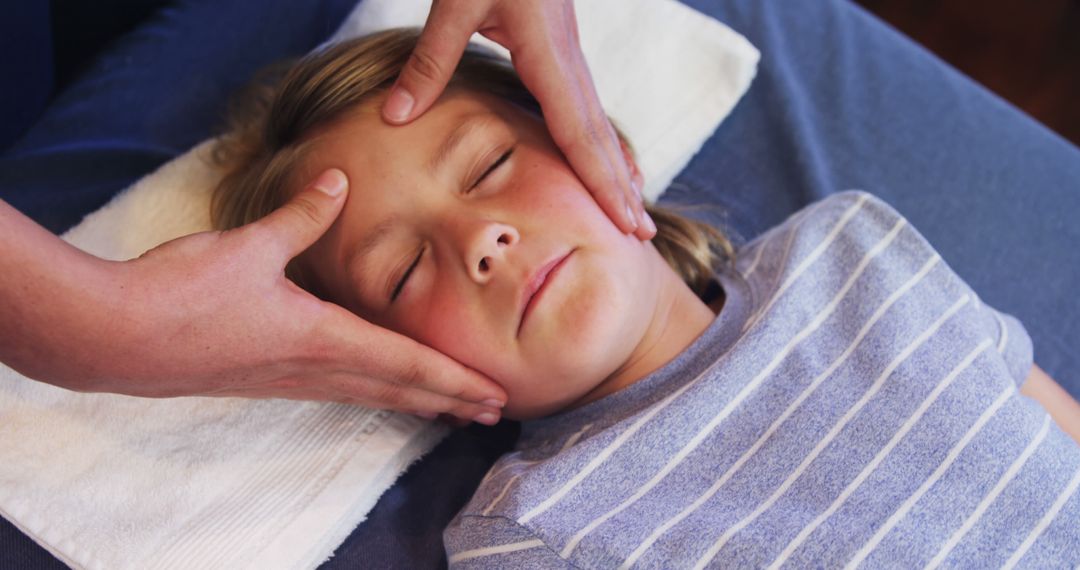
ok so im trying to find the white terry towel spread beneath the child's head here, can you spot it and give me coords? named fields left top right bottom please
left=0, top=0, right=758, bottom=569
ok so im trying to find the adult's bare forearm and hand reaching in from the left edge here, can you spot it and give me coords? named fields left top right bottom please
left=0, top=171, right=505, bottom=423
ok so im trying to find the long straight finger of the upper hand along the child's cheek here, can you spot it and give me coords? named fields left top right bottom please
left=512, top=3, right=638, bottom=233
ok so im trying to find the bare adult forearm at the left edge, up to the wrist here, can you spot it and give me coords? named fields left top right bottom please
left=0, top=201, right=126, bottom=390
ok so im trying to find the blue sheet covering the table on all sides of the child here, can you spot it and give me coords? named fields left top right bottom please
left=0, top=0, right=1080, bottom=567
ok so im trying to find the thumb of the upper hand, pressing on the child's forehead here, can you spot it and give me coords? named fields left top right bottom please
left=382, top=0, right=487, bottom=124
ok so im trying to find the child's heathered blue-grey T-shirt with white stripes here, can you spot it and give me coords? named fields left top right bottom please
left=445, top=192, right=1080, bottom=569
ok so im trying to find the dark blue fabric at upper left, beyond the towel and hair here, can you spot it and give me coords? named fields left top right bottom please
left=0, top=0, right=355, bottom=233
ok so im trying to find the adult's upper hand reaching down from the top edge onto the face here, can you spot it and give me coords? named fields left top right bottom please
left=382, top=0, right=656, bottom=240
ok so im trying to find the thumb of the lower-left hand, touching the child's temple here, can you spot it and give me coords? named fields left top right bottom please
left=255, top=168, right=349, bottom=259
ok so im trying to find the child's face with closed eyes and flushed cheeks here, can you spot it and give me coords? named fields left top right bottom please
left=296, top=91, right=671, bottom=419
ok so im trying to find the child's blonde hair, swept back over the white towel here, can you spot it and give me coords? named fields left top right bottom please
left=211, top=29, right=734, bottom=296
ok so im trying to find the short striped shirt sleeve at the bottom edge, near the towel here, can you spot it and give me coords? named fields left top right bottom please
left=443, top=515, right=575, bottom=570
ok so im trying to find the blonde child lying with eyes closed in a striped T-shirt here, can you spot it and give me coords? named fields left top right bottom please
left=214, top=31, right=1080, bottom=568
